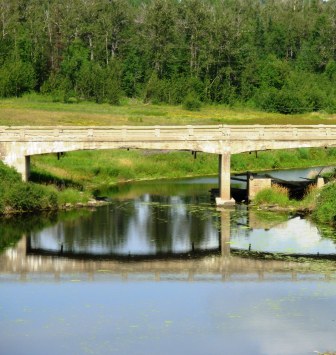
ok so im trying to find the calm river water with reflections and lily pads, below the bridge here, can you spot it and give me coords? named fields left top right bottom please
left=0, top=172, right=336, bottom=355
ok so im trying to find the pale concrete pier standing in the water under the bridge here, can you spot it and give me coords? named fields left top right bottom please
left=216, top=152, right=235, bottom=206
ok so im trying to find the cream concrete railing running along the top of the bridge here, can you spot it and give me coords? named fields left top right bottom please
left=0, top=125, right=336, bottom=142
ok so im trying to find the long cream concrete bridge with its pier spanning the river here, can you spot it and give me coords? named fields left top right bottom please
left=0, top=125, right=336, bottom=204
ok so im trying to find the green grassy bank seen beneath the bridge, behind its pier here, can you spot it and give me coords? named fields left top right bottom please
left=32, top=149, right=336, bottom=191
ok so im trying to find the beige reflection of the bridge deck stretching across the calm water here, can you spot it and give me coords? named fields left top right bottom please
left=0, top=236, right=336, bottom=281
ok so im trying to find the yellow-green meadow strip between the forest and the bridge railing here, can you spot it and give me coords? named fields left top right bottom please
left=0, top=94, right=336, bottom=126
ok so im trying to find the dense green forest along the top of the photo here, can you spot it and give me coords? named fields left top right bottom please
left=0, top=0, right=336, bottom=114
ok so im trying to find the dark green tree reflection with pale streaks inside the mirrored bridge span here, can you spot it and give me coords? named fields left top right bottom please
left=31, top=195, right=217, bottom=254
